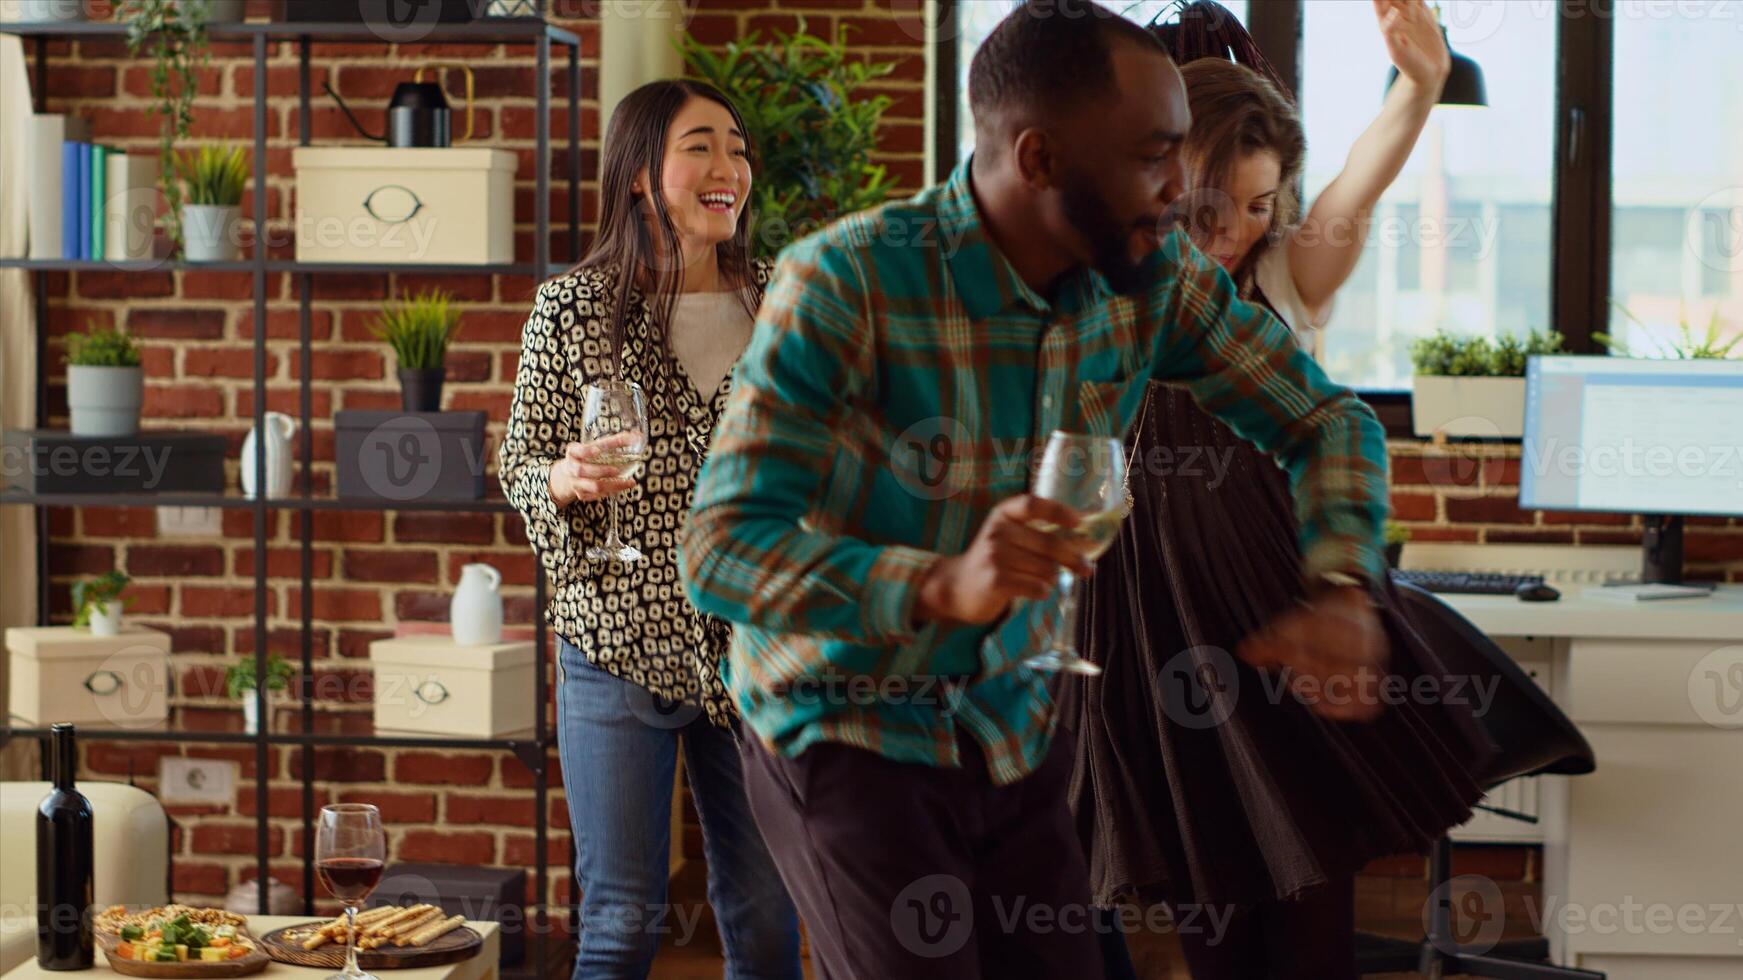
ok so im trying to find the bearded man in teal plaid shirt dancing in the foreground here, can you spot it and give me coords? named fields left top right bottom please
left=683, top=3, right=1386, bottom=980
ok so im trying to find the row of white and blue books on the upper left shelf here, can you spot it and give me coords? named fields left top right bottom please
left=24, top=113, right=157, bottom=262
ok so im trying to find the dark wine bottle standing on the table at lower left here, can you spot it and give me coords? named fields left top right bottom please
left=37, top=724, right=94, bottom=970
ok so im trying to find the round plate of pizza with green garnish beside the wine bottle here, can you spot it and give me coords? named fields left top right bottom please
left=92, top=905, right=268, bottom=980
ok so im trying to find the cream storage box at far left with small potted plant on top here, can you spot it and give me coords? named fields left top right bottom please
left=5, top=626, right=169, bottom=727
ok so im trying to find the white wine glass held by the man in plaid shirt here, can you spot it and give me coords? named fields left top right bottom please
left=1023, top=431, right=1126, bottom=675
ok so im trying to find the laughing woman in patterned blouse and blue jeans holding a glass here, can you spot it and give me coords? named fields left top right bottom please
left=498, top=80, right=800, bottom=980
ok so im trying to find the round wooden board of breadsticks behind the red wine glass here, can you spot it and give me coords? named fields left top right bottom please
left=260, top=905, right=485, bottom=970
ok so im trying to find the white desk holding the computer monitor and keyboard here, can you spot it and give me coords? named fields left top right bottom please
left=1441, top=586, right=1743, bottom=980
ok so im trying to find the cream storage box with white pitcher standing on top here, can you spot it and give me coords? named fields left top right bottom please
left=370, top=636, right=533, bottom=738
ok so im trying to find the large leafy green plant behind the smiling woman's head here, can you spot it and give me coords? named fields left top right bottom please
left=678, top=19, right=896, bottom=255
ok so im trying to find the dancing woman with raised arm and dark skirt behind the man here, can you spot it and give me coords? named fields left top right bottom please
left=1063, top=0, right=1492, bottom=980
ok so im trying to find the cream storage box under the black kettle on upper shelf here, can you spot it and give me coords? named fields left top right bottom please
left=291, top=146, right=516, bottom=265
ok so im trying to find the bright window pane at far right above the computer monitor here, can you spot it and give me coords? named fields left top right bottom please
left=1609, top=2, right=1743, bottom=354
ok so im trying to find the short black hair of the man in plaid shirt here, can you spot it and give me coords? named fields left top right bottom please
left=969, top=0, right=1168, bottom=131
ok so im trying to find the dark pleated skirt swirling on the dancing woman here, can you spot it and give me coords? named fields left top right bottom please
left=1060, top=378, right=1492, bottom=907
